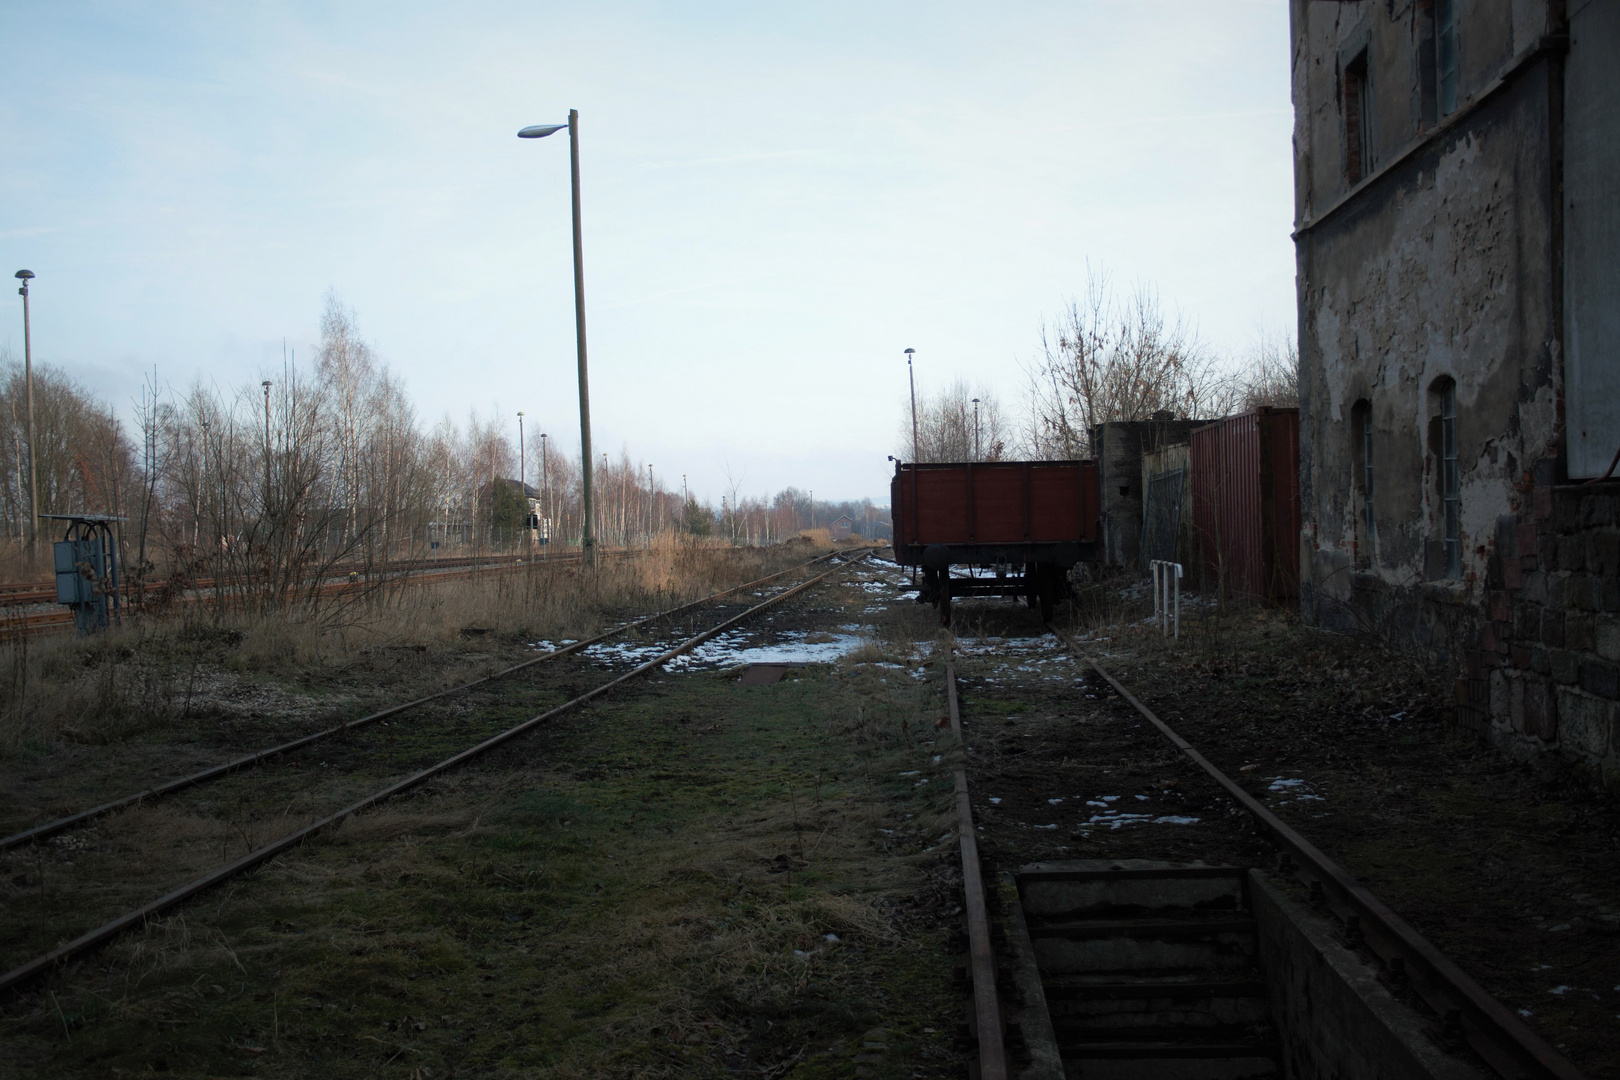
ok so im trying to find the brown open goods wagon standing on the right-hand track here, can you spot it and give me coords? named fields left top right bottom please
left=889, top=461, right=1102, bottom=625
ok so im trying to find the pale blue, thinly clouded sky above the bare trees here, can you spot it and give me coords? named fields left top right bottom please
left=0, top=0, right=1294, bottom=504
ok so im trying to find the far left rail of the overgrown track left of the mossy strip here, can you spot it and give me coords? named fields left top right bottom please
left=0, top=554, right=855, bottom=852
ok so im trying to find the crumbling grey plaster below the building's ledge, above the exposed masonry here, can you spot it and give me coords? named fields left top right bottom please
left=1301, top=80, right=1557, bottom=602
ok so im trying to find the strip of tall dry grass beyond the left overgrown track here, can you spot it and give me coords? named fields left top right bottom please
left=0, top=538, right=825, bottom=758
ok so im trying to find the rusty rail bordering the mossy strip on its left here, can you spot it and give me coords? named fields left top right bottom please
left=0, top=551, right=867, bottom=989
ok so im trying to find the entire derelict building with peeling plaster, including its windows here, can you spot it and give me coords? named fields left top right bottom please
left=1291, top=0, right=1620, bottom=782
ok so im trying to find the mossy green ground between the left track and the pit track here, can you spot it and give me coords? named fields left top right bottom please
left=0, top=647, right=959, bottom=1078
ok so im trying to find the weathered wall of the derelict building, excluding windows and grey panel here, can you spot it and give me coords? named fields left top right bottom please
left=1294, top=0, right=1620, bottom=782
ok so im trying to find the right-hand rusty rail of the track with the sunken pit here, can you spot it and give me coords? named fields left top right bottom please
left=1048, top=627, right=1584, bottom=1080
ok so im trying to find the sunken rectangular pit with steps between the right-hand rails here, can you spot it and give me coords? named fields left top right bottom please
left=978, top=860, right=1490, bottom=1080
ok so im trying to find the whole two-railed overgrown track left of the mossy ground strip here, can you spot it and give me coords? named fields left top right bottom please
left=0, top=551, right=867, bottom=989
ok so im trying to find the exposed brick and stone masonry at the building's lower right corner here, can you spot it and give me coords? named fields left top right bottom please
left=1456, top=460, right=1620, bottom=787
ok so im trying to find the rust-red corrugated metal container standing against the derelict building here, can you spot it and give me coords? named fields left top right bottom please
left=1192, top=408, right=1299, bottom=604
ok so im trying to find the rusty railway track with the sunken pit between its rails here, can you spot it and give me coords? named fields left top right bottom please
left=946, top=627, right=1583, bottom=1080
